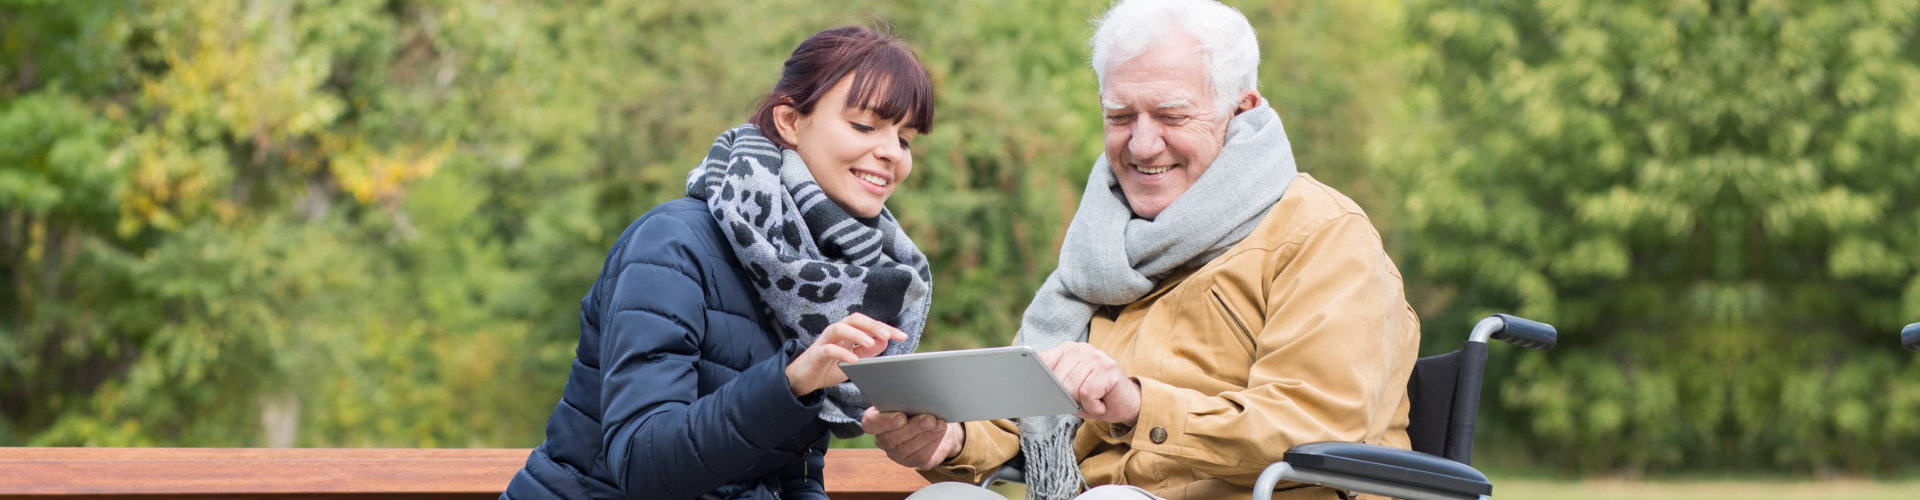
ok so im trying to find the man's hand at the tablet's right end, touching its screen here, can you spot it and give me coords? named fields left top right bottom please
left=1041, top=342, right=1140, bottom=427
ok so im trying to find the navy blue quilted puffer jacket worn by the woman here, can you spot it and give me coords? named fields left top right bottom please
left=501, top=198, right=828, bottom=500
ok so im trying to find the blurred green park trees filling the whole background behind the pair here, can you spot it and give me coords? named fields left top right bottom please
left=0, top=0, right=1920, bottom=494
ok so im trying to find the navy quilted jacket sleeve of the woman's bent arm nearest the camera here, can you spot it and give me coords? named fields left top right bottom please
left=599, top=217, right=820, bottom=498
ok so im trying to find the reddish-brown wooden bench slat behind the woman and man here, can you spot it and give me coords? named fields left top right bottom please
left=0, top=448, right=927, bottom=500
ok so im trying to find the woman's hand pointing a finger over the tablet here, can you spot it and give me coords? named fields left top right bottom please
left=787, top=313, right=906, bottom=398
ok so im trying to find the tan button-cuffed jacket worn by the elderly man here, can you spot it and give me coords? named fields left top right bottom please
left=924, top=173, right=1419, bottom=500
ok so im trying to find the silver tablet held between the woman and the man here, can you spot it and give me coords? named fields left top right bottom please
left=841, top=346, right=1079, bottom=421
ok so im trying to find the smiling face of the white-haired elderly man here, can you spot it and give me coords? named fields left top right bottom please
left=1100, top=29, right=1231, bottom=219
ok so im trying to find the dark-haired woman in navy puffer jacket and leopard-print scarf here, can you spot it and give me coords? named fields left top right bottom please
left=501, top=27, right=933, bottom=498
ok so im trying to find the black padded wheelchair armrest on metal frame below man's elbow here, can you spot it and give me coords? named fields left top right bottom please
left=1256, top=442, right=1494, bottom=498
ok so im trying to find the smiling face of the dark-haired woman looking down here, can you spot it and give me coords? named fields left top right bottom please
left=774, top=75, right=918, bottom=217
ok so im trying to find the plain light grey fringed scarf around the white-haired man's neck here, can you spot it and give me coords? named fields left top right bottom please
left=1020, top=102, right=1298, bottom=500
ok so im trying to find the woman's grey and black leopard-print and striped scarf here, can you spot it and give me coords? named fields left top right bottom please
left=687, top=125, right=933, bottom=438
